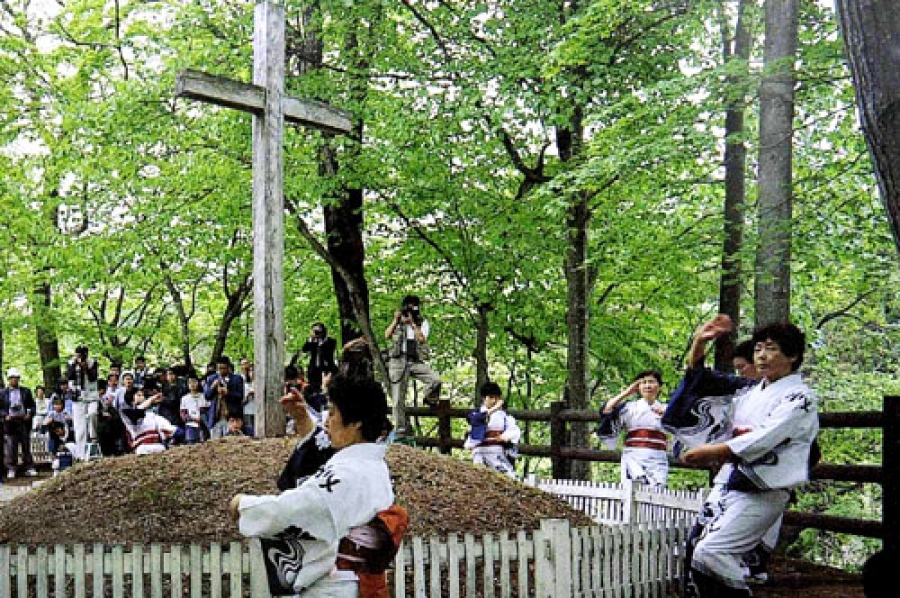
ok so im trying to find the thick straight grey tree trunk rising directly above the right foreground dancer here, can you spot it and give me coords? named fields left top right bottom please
left=755, top=0, right=800, bottom=326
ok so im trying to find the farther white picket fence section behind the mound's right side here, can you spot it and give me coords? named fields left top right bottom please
left=525, top=476, right=707, bottom=524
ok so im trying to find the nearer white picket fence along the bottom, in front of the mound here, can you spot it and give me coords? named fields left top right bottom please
left=0, top=519, right=688, bottom=598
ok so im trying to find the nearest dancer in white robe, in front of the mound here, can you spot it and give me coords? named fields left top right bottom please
left=231, top=375, right=394, bottom=598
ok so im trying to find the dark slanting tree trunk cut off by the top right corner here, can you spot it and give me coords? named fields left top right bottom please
left=837, top=0, right=900, bottom=258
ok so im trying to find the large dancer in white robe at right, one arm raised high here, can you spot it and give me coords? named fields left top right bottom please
left=665, top=316, right=818, bottom=598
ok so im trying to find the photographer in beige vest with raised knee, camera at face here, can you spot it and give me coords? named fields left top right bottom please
left=384, top=295, right=441, bottom=436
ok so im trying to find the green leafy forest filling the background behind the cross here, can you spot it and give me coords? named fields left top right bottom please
left=0, top=0, right=900, bottom=562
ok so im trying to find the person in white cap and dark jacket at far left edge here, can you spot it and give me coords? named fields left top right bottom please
left=0, top=368, right=37, bottom=478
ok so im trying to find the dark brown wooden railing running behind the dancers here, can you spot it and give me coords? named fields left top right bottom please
left=407, top=396, right=900, bottom=549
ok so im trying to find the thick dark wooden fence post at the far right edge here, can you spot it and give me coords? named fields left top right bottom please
left=881, top=396, right=900, bottom=555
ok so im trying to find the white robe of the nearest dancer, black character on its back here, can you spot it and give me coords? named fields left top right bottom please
left=238, top=443, right=394, bottom=597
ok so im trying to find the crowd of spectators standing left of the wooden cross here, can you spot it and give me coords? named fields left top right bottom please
left=0, top=347, right=272, bottom=477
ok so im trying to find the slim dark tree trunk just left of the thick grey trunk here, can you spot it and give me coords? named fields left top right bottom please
left=715, top=0, right=751, bottom=370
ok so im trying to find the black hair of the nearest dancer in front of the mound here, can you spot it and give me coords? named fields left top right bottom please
left=328, top=374, right=388, bottom=442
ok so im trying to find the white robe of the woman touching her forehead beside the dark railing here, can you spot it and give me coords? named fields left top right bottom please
left=602, top=398, right=669, bottom=487
